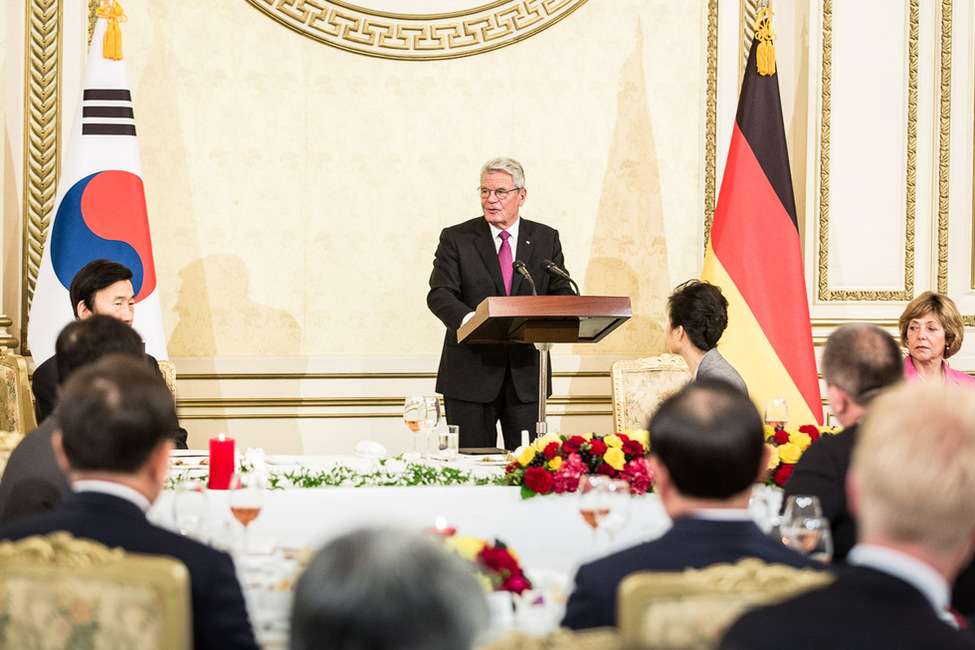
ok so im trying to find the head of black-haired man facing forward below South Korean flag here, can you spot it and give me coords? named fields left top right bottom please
left=68, top=260, right=135, bottom=325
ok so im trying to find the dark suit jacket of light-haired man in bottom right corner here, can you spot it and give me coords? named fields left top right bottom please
left=721, top=567, right=975, bottom=650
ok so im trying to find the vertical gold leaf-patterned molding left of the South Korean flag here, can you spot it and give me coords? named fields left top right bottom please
left=20, top=0, right=62, bottom=344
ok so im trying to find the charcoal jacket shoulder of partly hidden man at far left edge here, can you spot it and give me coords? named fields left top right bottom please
left=0, top=418, right=71, bottom=525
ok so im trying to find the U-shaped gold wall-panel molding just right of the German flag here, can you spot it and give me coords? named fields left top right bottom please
left=818, top=0, right=920, bottom=302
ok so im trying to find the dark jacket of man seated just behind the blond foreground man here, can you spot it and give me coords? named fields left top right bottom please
left=782, top=424, right=857, bottom=562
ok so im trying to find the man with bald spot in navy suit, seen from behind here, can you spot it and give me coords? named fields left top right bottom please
left=562, top=379, right=819, bottom=629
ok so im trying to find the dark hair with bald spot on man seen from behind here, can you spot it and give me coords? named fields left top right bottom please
left=649, top=378, right=765, bottom=499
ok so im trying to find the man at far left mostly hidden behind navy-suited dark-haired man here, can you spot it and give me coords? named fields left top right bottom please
left=0, top=316, right=146, bottom=525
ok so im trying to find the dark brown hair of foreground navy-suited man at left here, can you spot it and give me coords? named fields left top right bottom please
left=54, top=354, right=179, bottom=474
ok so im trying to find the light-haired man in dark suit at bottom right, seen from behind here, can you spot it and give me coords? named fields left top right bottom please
left=721, top=385, right=975, bottom=650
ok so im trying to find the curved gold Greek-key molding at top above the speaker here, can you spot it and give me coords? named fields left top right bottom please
left=247, top=0, right=586, bottom=61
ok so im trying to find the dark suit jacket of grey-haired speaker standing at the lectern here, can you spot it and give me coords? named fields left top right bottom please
left=427, top=217, right=573, bottom=402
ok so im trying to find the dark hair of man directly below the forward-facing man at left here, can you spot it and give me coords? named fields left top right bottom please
left=54, top=314, right=146, bottom=384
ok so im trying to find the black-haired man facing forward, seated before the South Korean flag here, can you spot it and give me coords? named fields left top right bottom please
left=31, top=260, right=186, bottom=449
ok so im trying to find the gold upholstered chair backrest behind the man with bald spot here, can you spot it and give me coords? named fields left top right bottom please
left=617, top=558, right=833, bottom=650
